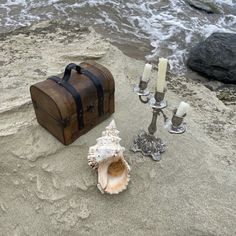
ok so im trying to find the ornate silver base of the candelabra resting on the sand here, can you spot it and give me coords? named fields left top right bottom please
left=131, top=131, right=166, bottom=161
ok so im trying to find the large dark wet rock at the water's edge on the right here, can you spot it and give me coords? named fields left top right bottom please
left=187, top=33, right=236, bottom=84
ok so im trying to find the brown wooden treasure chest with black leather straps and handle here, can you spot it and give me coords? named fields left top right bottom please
left=30, top=61, right=115, bottom=145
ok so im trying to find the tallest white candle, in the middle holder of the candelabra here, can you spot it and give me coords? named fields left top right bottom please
left=156, top=58, right=168, bottom=93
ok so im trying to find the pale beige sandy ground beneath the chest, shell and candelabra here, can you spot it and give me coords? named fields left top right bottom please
left=0, top=22, right=236, bottom=236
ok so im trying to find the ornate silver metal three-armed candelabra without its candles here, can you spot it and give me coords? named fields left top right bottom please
left=131, top=79, right=186, bottom=161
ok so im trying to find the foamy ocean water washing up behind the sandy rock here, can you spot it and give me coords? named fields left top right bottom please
left=0, top=0, right=236, bottom=73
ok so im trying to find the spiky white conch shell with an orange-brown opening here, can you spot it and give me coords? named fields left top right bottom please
left=88, top=120, right=130, bottom=194
